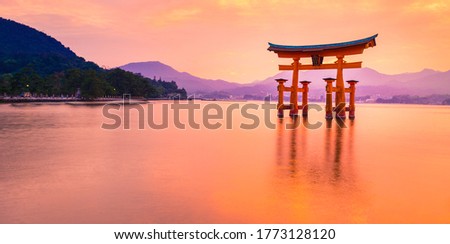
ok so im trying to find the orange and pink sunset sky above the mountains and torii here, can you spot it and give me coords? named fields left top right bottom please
left=0, top=0, right=450, bottom=83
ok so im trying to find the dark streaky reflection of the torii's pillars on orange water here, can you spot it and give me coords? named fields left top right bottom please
left=276, top=117, right=354, bottom=183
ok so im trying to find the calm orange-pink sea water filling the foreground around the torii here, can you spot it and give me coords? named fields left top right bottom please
left=0, top=102, right=450, bottom=223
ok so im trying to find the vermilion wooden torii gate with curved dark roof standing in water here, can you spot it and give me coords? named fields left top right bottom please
left=267, top=34, right=378, bottom=119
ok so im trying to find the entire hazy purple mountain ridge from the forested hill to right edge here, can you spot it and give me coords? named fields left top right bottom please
left=120, top=61, right=450, bottom=98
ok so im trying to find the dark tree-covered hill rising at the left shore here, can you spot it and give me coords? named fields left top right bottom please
left=0, top=17, right=186, bottom=99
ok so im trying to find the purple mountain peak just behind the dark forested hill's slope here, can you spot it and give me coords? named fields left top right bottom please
left=119, top=61, right=241, bottom=94
